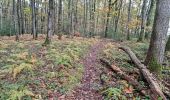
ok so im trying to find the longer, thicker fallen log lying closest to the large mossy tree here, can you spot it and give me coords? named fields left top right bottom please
left=119, top=47, right=167, bottom=100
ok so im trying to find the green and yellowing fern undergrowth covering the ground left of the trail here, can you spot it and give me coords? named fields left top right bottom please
left=0, top=39, right=97, bottom=100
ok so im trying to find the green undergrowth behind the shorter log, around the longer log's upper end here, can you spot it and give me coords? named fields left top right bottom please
left=101, top=40, right=149, bottom=69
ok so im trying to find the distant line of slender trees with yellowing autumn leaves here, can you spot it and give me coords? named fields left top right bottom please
left=0, top=0, right=159, bottom=41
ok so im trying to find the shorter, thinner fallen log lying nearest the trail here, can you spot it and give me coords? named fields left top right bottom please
left=100, top=59, right=146, bottom=96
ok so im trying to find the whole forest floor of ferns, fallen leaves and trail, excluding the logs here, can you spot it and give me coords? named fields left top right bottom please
left=0, top=35, right=170, bottom=100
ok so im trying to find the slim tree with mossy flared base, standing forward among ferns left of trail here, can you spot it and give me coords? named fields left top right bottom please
left=44, top=0, right=54, bottom=45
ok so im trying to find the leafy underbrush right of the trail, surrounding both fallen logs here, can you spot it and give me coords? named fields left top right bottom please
left=100, top=41, right=170, bottom=100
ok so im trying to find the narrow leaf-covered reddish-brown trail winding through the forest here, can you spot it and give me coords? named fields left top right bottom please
left=67, top=41, right=105, bottom=100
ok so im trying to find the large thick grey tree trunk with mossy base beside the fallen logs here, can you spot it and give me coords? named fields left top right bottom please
left=145, top=0, right=170, bottom=72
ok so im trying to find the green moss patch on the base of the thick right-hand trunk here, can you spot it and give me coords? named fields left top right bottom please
left=149, top=57, right=162, bottom=75
